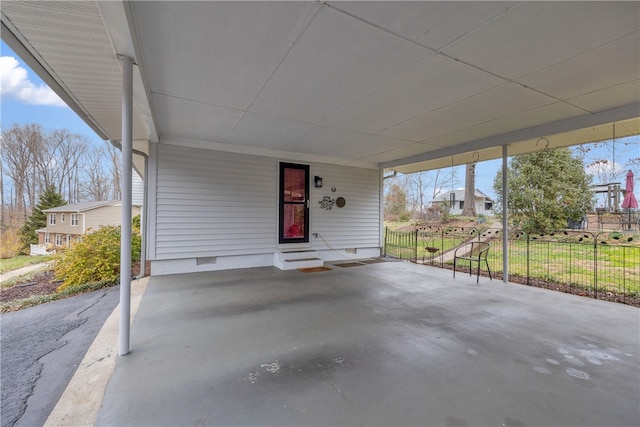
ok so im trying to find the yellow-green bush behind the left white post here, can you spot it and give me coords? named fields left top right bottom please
left=54, top=226, right=141, bottom=291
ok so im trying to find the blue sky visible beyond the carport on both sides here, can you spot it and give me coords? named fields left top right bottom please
left=0, top=42, right=640, bottom=206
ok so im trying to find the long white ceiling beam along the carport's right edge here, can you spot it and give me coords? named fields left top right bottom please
left=380, top=102, right=640, bottom=169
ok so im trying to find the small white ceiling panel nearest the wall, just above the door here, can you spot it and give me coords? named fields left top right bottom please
left=224, top=113, right=314, bottom=150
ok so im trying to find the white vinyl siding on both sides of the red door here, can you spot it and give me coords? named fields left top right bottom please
left=154, top=144, right=380, bottom=261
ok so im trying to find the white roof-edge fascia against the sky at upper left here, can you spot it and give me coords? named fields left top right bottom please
left=1, top=13, right=109, bottom=140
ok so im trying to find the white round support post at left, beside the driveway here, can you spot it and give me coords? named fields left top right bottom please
left=119, top=56, right=133, bottom=356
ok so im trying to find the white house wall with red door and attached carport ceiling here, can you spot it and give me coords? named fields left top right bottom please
left=1, top=0, right=640, bottom=275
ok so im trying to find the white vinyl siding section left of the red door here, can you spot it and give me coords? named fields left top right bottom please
left=156, top=145, right=278, bottom=260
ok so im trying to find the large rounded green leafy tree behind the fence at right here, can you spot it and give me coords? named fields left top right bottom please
left=493, top=148, right=593, bottom=233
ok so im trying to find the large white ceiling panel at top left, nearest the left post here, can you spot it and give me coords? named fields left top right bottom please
left=135, top=1, right=320, bottom=109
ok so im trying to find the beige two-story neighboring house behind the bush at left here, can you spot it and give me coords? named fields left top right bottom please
left=36, top=200, right=140, bottom=248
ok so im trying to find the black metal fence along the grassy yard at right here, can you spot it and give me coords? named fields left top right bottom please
left=385, top=226, right=640, bottom=298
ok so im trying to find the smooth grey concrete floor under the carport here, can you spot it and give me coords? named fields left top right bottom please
left=96, top=262, right=640, bottom=426
